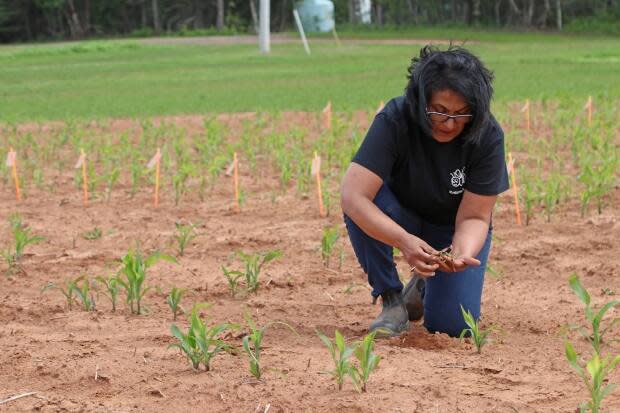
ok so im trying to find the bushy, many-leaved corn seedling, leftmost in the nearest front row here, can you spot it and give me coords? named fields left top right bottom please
left=168, top=305, right=235, bottom=371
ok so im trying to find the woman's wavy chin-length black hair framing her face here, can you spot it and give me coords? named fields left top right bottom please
left=405, top=45, right=493, bottom=144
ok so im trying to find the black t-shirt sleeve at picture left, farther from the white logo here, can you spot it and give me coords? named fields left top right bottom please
left=353, top=112, right=398, bottom=181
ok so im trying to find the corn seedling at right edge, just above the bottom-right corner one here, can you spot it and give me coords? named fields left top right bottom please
left=568, top=273, right=620, bottom=355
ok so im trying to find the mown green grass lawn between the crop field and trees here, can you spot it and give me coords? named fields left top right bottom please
left=0, top=31, right=620, bottom=123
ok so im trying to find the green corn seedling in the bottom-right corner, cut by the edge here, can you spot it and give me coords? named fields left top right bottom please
left=565, top=341, right=620, bottom=413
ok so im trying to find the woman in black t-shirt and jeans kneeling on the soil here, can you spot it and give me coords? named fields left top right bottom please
left=341, top=46, right=508, bottom=336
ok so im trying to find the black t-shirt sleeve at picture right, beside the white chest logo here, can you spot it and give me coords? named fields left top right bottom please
left=465, top=124, right=509, bottom=195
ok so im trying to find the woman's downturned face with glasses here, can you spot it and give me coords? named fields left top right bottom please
left=426, top=89, right=471, bottom=143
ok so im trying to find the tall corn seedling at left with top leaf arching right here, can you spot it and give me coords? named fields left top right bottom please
left=118, top=250, right=176, bottom=314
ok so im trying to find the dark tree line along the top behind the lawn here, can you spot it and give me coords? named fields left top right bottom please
left=0, top=0, right=620, bottom=42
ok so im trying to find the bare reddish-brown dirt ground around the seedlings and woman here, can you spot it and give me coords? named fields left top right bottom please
left=0, top=112, right=620, bottom=412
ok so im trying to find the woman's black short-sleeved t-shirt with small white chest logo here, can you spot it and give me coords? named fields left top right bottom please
left=353, top=96, right=509, bottom=225
